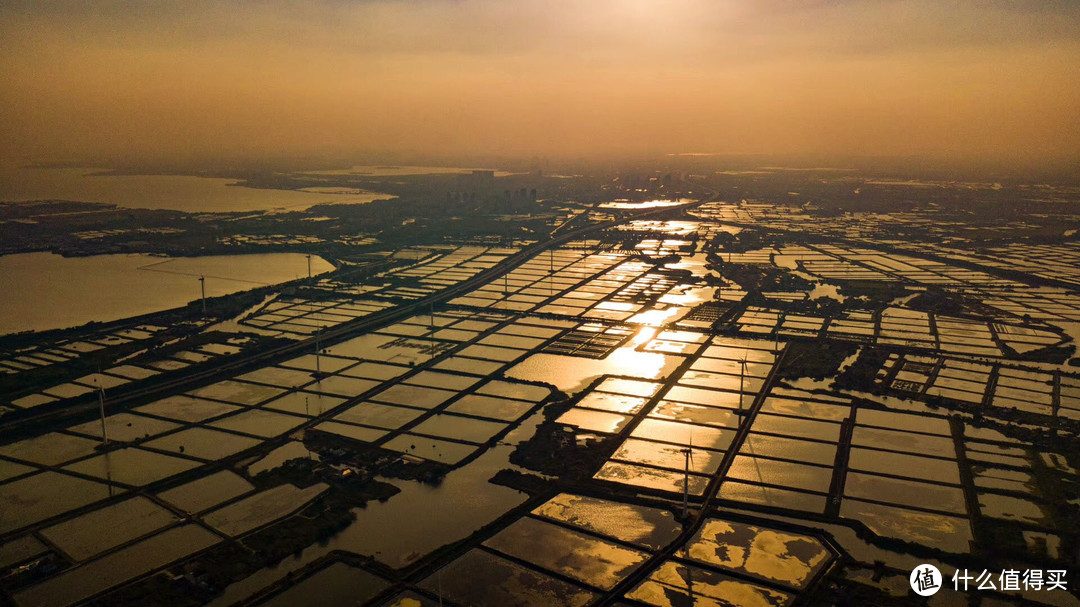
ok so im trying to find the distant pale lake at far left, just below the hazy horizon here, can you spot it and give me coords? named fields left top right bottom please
left=0, top=167, right=393, bottom=213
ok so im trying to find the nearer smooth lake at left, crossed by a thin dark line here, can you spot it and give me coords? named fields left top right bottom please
left=0, top=253, right=334, bottom=335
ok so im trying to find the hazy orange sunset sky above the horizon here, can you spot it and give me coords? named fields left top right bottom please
left=0, top=0, right=1080, bottom=164
